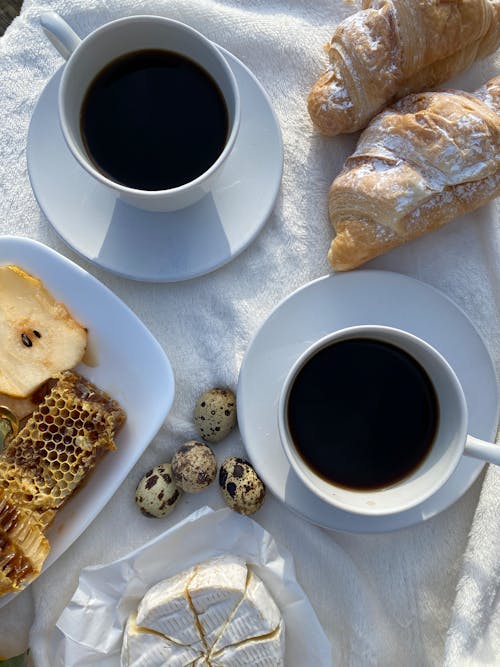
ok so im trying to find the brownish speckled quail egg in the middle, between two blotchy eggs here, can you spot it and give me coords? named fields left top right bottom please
left=172, top=440, right=217, bottom=493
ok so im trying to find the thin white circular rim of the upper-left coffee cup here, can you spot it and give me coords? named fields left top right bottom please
left=58, top=14, right=241, bottom=199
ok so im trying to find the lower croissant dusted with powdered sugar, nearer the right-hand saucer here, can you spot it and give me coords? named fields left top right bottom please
left=328, top=76, right=500, bottom=271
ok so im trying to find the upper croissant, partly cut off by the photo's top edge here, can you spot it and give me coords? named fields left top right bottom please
left=308, top=0, right=500, bottom=136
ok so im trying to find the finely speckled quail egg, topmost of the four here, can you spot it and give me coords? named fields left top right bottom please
left=194, top=387, right=236, bottom=442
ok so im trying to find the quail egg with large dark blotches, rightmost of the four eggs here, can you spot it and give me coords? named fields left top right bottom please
left=219, top=456, right=266, bottom=514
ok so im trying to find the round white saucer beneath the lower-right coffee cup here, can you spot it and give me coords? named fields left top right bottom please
left=237, top=271, right=499, bottom=533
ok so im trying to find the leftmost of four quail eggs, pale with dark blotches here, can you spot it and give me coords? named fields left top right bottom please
left=135, top=463, right=182, bottom=518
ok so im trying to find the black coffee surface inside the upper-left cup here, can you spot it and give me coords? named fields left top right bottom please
left=80, top=50, right=228, bottom=190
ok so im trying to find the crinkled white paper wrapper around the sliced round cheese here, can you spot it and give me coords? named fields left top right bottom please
left=47, top=507, right=332, bottom=667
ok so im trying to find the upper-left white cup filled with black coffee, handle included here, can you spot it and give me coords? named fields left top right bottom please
left=40, top=12, right=240, bottom=211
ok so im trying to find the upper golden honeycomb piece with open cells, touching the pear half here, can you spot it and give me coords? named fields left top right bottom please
left=0, top=371, right=125, bottom=528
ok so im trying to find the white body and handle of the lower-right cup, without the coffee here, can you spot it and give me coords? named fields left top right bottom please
left=278, top=325, right=500, bottom=516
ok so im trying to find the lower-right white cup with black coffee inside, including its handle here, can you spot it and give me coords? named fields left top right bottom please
left=278, top=325, right=500, bottom=515
